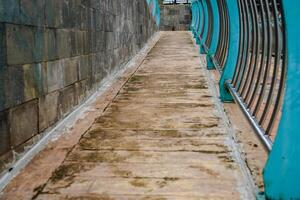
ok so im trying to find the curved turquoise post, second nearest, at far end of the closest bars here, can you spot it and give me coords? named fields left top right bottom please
left=219, top=0, right=240, bottom=102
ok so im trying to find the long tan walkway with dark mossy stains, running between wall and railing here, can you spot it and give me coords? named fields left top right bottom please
left=1, top=32, right=253, bottom=200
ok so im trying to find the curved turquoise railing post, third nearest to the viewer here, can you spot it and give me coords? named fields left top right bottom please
left=206, top=0, right=220, bottom=69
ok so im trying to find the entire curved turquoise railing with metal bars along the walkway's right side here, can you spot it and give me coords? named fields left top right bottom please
left=191, top=0, right=300, bottom=199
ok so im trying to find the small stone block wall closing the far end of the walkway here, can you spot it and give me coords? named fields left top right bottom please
left=160, top=4, right=192, bottom=31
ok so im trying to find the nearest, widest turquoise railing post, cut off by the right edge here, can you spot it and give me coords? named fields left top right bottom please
left=263, top=0, right=300, bottom=199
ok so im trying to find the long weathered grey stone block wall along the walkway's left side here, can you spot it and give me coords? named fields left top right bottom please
left=0, top=0, right=157, bottom=171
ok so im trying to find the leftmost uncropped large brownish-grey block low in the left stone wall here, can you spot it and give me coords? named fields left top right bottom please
left=9, top=100, right=38, bottom=147
